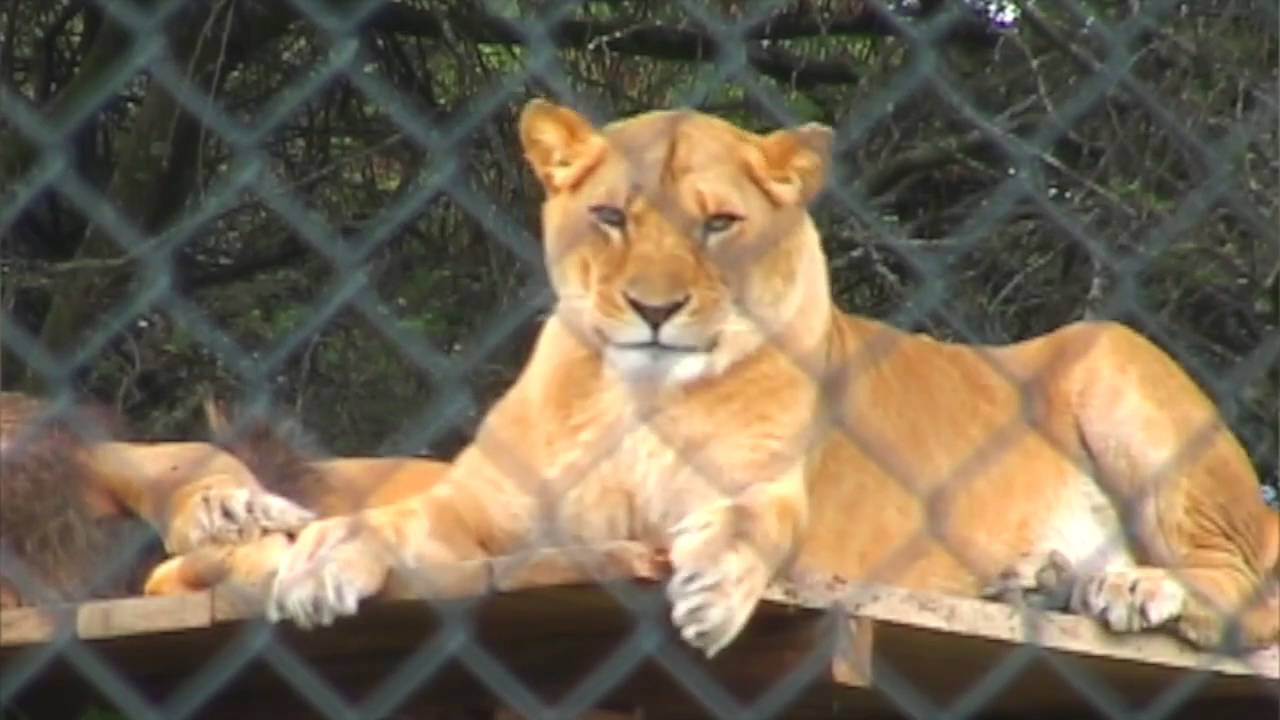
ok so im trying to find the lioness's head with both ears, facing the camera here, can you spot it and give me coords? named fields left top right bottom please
left=521, top=100, right=831, bottom=383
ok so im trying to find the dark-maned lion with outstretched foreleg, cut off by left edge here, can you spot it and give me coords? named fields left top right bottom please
left=0, top=392, right=312, bottom=607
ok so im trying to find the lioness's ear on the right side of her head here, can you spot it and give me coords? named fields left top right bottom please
left=749, top=123, right=832, bottom=205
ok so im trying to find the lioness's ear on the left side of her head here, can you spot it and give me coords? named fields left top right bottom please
left=520, top=100, right=604, bottom=193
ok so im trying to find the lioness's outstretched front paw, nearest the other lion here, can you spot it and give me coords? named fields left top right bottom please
left=266, top=518, right=388, bottom=629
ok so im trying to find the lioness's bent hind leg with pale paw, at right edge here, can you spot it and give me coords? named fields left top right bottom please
left=1073, top=325, right=1280, bottom=647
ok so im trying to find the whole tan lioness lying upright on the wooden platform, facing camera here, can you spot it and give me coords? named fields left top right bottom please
left=268, top=100, right=1280, bottom=655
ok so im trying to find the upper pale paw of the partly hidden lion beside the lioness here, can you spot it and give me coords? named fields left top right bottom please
left=165, top=475, right=315, bottom=555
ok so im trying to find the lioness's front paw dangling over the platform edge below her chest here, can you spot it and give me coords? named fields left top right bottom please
left=667, top=507, right=769, bottom=657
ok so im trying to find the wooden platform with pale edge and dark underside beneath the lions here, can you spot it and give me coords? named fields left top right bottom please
left=0, top=548, right=1280, bottom=720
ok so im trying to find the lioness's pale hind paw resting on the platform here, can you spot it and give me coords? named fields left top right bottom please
left=1071, top=568, right=1187, bottom=633
